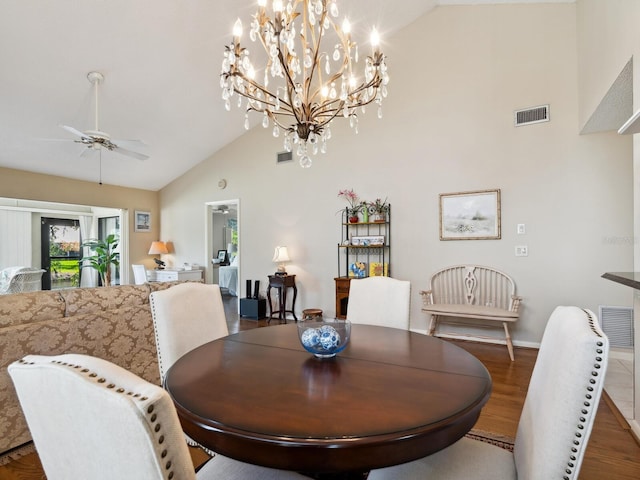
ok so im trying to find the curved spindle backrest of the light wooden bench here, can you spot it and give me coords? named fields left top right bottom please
left=430, top=265, right=516, bottom=310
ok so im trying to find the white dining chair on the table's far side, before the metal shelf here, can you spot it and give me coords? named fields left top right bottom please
left=347, top=277, right=411, bottom=330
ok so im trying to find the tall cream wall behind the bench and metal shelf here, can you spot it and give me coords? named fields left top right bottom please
left=160, top=4, right=633, bottom=344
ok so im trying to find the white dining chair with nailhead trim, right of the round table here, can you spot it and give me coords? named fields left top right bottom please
left=369, top=307, right=609, bottom=480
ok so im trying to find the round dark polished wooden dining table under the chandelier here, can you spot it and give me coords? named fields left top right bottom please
left=164, top=324, right=491, bottom=478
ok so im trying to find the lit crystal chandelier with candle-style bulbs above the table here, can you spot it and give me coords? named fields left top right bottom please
left=220, top=0, right=389, bottom=167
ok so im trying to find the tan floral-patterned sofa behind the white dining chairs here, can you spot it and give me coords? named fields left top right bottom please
left=0, top=282, right=185, bottom=463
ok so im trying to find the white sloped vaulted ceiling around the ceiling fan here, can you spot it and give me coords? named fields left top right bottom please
left=0, top=0, right=573, bottom=190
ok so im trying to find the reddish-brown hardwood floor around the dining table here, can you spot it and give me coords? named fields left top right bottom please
left=0, top=297, right=640, bottom=480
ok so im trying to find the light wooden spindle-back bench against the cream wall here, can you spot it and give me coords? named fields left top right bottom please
left=420, top=265, right=521, bottom=361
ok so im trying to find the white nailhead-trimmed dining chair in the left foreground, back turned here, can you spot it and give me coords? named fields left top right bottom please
left=8, top=354, right=305, bottom=480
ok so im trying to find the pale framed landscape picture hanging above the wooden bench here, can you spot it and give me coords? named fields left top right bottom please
left=440, top=189, right=501, bottom=240
